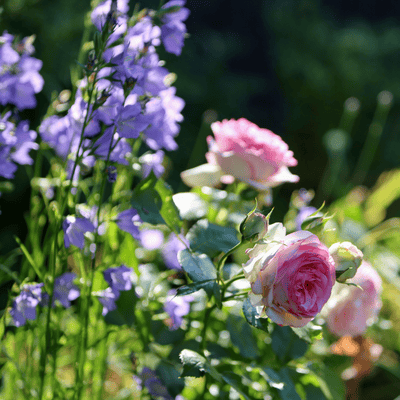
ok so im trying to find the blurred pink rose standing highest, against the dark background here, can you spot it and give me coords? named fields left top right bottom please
left=181, top=118, right=299, bottom=190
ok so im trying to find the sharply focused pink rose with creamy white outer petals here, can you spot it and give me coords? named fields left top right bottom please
left=243, top=223, right=335, bottom=327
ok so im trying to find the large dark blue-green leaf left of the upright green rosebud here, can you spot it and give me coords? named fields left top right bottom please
left=186, top=219, right=239, bottom=258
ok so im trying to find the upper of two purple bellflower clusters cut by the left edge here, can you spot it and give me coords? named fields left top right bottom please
left=0, top=32, right=44, bottom=110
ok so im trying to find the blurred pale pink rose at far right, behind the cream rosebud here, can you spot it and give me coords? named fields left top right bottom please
left=323, top=261, right=382, bottom=336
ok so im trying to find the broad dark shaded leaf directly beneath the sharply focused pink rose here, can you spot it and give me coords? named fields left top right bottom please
left=271, top=325, right=308, bottom=362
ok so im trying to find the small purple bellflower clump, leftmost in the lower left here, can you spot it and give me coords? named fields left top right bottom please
left=10, top=283, right=44, bottom=327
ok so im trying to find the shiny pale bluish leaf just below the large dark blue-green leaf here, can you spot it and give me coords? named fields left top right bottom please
left=178, top=249, right=217, bottom=282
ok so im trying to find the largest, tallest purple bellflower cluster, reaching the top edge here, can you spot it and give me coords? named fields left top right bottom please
left=39, top=0, right=188, bottom=179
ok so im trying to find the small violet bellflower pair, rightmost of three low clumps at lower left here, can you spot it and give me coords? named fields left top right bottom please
left=97, top=265, right=133, bottom=315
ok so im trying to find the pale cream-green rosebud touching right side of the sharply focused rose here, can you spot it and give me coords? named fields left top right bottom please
left=329, top=242, right=363, bottom=283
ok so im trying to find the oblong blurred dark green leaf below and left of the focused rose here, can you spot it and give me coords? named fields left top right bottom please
left=226, top=314, right=259, bottom=359
